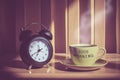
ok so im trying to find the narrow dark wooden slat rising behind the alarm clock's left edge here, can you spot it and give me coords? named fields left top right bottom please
left=16, top=0, right=25, bottom=52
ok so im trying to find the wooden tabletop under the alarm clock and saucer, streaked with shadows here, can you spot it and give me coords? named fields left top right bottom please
left=0, top=54, right=120, bottom=80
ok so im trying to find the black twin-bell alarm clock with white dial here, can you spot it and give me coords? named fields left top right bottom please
left=19, top=23, right=53, bottom=67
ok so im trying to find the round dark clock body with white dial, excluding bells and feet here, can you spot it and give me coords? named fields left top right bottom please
left=20, top=35, right=53, bottom=67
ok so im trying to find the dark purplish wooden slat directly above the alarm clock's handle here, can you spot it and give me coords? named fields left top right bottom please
left=24, top=0, right=41, bottom=32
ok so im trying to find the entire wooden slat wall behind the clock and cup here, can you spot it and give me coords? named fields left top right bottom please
left=0, top=0, right=120, bottom=56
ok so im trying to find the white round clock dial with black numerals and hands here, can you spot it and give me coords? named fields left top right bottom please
left=29, top=41, right=49, bottom=62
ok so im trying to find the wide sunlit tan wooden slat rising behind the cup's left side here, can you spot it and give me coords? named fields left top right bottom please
left=68, top=0, right=80, bottom=45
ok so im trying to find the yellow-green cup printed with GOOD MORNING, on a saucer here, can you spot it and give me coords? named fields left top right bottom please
left=69, top=44, right=106, bottom=66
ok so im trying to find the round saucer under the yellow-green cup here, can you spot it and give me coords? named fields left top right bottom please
left=61, top=59, right=108, bottom=70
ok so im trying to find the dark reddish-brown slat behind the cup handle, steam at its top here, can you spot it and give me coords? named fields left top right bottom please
left=105, top=0, right=116, bottom=53
